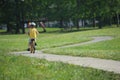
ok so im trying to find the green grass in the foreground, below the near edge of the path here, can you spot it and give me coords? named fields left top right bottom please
left=0, top=54, right=120, bottom=80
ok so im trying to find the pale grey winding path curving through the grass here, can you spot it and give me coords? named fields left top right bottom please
left=14, top=36, right=120, bottom=74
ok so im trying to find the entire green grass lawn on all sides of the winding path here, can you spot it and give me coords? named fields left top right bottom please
left=0, top=28, right=120, bottom=80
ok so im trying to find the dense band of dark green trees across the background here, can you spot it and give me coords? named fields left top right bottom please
left=0, top=0, right=120, bottom=33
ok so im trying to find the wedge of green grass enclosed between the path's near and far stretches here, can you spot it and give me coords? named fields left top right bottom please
left=44, top=38, right=120, bottom=60
